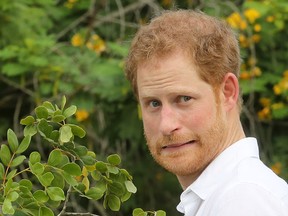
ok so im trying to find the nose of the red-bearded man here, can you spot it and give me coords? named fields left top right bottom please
left=159, top=105, right=180, bottom=135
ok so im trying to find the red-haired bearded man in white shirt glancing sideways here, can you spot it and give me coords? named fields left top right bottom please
left=126, top=10, right=288, bottom=216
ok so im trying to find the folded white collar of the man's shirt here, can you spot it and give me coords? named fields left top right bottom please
left=177, top=137, right=259, bottom=213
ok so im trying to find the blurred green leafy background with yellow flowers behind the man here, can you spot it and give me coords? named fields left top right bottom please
left=0, top=0, right=288, bottom=216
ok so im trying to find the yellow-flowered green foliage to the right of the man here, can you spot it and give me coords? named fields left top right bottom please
left=226, top=0, right=288, bottom=179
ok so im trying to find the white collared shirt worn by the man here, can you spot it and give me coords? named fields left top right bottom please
left=177, top=138, right=288, bottom=216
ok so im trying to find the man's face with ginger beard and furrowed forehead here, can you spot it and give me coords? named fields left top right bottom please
left=137, top=52, right=227, bottom=176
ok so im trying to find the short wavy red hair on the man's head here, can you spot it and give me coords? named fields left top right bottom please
left=125, top=10, right=241, bottom=96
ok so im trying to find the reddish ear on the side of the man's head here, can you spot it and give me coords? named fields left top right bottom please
left=222, top=73, right=239, bottom=111
